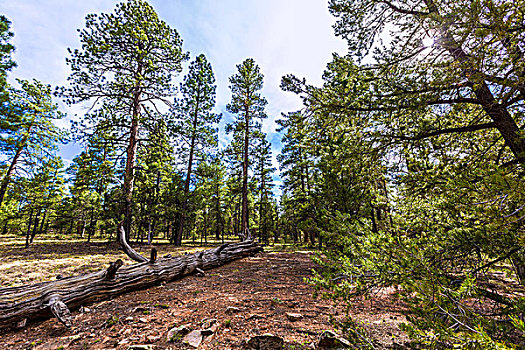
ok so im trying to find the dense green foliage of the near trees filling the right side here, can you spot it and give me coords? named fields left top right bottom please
left=280, top=0, right=525, bottom=349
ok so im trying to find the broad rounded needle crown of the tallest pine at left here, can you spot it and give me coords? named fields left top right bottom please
left=62, top=0, right=187, bottom=107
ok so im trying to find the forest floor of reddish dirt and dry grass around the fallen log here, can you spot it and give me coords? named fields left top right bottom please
left=0, top=238, right=408, bottom=350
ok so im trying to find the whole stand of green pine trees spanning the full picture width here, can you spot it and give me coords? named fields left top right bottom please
left=0, top=0, right=525, bottom=349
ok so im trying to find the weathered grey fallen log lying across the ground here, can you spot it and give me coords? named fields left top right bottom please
left=0, top=241, right=263, bottom=329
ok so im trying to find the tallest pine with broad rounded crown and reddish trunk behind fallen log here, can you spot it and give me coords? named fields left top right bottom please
left=62, top=0, right=187, bottom=245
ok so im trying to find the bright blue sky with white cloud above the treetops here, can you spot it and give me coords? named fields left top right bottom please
left=0, top=0, right=346, bottom=191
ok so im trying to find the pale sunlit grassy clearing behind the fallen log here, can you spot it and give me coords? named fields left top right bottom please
left=0, top=235, right=311, bottom=287
